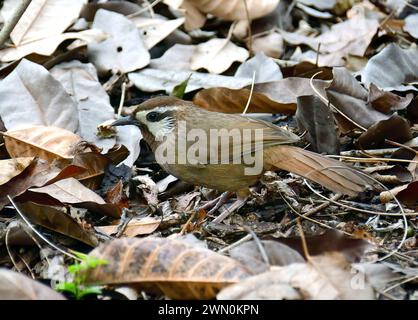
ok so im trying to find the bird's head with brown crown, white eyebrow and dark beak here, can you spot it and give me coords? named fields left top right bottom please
left=111, top=97, right=191, bottom=140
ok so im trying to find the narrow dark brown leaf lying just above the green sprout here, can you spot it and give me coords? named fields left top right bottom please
left=18, top=202, right=99, bottom=247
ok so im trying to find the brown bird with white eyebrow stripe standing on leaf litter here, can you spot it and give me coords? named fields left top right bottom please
left=111, top=96, right=373, bottom=214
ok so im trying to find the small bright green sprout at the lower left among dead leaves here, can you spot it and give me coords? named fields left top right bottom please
left=55, top=252, right=108, bottom=300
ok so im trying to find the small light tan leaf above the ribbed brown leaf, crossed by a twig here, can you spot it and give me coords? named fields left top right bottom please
left=96, top=217, right=161, bottom=238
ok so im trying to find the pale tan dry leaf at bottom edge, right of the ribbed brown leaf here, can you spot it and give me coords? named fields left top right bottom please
left=217, top=252, right=375, bottom=300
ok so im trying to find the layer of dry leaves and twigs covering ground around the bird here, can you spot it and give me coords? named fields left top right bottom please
left=0, top=0, right=418, bottom=299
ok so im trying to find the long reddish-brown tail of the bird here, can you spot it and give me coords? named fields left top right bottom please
left=264, top=146, right=374, bottom=196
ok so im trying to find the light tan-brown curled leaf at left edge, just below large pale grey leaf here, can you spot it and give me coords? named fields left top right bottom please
left=3, top=126, right=81, bottom=160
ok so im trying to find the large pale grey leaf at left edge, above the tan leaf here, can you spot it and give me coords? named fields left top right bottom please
left=0, top=59, right=78, bottom=132
